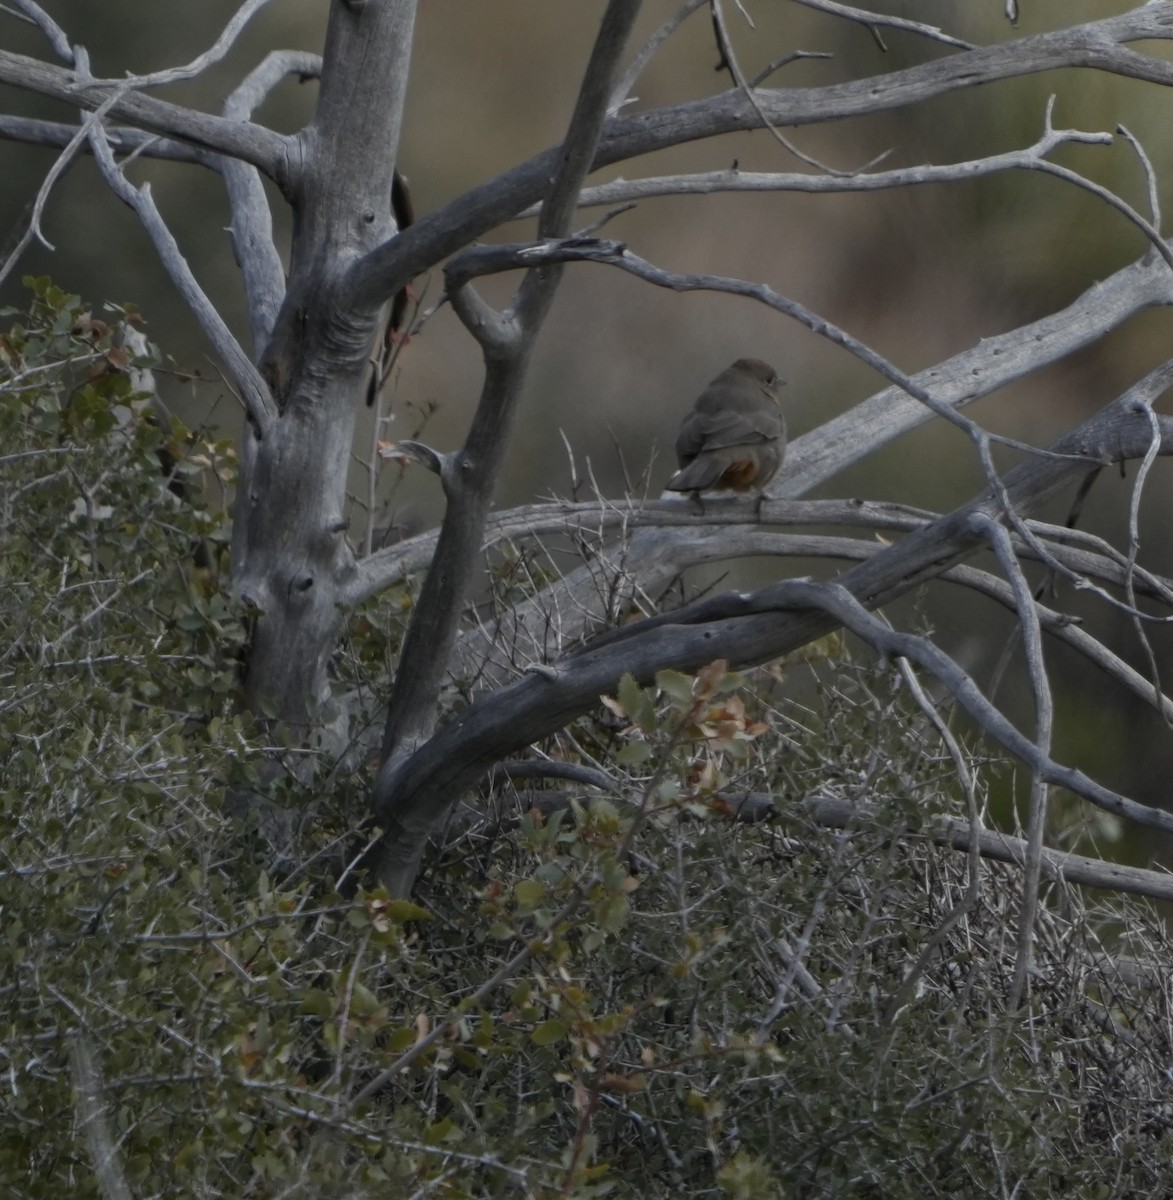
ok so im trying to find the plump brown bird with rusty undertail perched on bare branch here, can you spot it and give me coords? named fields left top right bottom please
left=667, top=359, right=786, bottom=497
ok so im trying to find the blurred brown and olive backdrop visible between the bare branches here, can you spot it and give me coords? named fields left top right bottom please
left=0, top=0, right=1173, bottom=864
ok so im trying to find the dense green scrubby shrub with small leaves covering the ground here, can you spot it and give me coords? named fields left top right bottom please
left=0, top=281, right=1173, bottom=1198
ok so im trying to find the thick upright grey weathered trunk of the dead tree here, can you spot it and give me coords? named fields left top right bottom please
left=233, top=0, right=415, bottom=724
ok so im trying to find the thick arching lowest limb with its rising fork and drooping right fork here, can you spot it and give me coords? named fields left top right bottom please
left=373, top=398, right=1173, bottom=890
